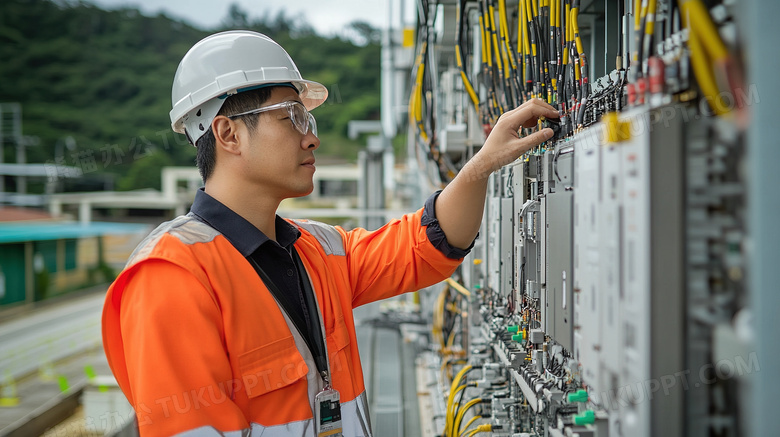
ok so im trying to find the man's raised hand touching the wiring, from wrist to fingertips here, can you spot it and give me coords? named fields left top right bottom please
left=461, top=99, right=558, bottom=180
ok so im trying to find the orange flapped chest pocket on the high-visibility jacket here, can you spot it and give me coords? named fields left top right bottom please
left=238, top=336, right=309, bottom=398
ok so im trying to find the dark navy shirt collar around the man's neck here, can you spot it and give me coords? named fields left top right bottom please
left=190, top=188, right=301, bottom=257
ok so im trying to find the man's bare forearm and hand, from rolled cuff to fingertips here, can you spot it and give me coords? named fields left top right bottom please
left=436, top=99, right=558, bottom=249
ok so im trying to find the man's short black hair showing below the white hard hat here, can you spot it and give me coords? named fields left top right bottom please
left=195, top=87, right=275, bottom=182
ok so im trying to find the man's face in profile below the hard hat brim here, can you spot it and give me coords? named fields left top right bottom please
left=241, top=87, right=320, bottom=199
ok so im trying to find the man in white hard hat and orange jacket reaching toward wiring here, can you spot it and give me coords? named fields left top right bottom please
left=103, top=31, right=557, bottom=436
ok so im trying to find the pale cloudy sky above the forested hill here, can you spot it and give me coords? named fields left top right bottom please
left=89, top=0, right=406, bottom=35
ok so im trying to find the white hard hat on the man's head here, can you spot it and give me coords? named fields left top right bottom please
left=170, top=30, right=328, bottom=145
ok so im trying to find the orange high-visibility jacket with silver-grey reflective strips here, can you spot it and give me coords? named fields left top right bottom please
left=103, top=209, right=460, bottom=436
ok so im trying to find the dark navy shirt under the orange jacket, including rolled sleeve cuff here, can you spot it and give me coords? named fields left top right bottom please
left=190, top=188, right=474, bottom=372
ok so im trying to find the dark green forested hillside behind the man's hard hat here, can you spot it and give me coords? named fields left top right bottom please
left=0, top=0, right=380, bottom=189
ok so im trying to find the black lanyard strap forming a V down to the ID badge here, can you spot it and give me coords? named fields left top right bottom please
left=247, top=252, right=330, bottom=387
